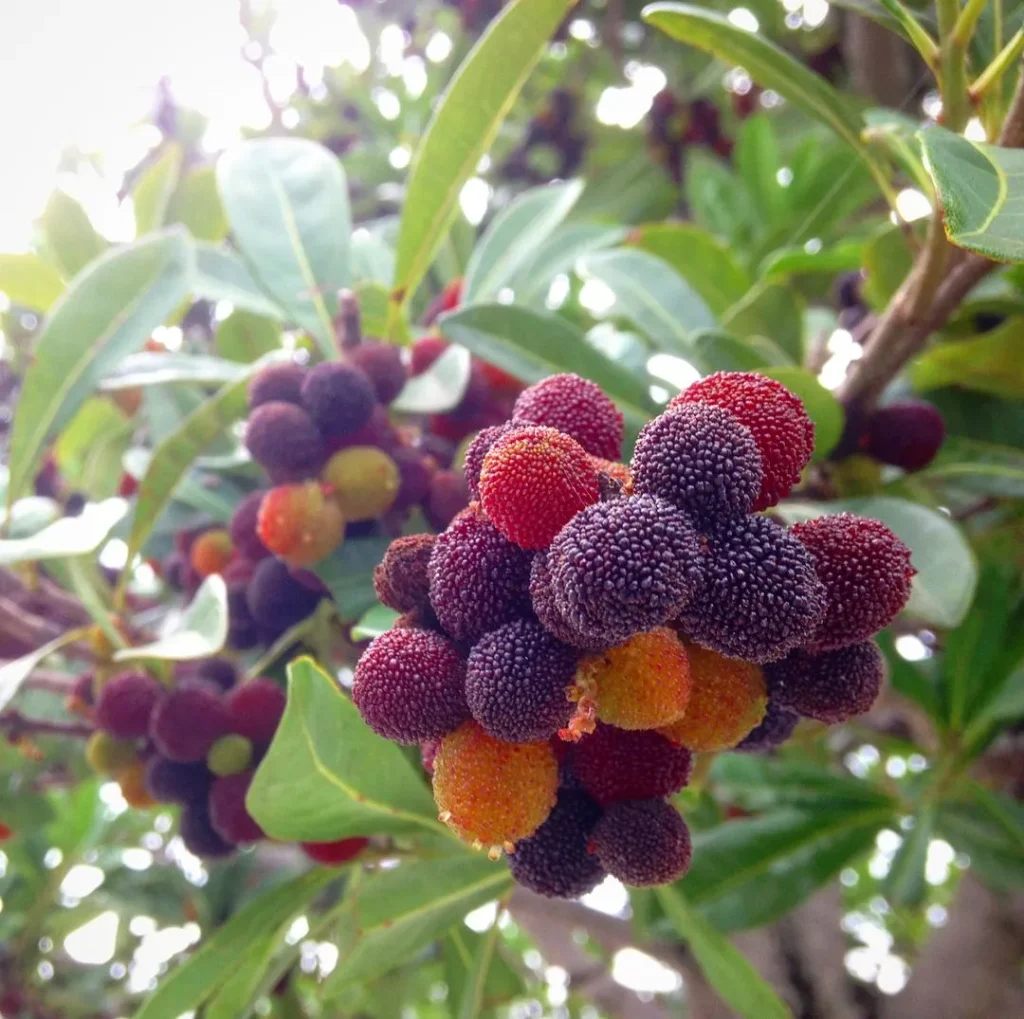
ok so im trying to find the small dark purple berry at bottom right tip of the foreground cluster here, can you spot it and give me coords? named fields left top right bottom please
left=591, top=800, right=693, bottom=888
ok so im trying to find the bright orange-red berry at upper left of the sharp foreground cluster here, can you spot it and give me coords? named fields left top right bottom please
left=480, top=425, right=600, bottom=549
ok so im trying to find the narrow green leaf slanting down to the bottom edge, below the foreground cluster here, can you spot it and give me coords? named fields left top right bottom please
left=655, top=885, right=793, bottom=1019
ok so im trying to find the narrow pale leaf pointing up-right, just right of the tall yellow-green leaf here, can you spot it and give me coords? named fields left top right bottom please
left=461, top=180, right=583, bottom=306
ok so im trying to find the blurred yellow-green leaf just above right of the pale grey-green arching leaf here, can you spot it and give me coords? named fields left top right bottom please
left=630, top=223, right=754, bottom=315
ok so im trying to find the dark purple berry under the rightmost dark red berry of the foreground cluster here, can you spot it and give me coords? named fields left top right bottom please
left=766, top=640, right=885, bottom=725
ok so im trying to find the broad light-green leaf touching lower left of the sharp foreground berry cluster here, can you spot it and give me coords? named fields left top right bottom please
left=246, top=657, right=444, bottom=839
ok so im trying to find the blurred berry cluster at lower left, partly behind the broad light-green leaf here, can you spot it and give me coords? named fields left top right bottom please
left=69, top=657, right=368, bottom=863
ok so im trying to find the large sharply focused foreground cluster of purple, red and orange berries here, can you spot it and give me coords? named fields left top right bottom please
left=352, top=373, right=913, bottom=896
